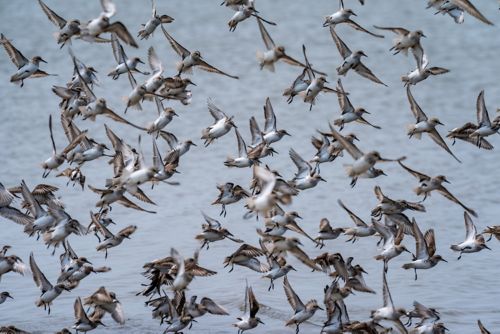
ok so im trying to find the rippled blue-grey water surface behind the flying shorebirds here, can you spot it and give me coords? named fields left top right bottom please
left=0, top=0, right=500, bottom=333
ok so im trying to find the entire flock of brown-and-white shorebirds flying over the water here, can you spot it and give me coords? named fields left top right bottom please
left=0, top=0, right=500, bottom=334
